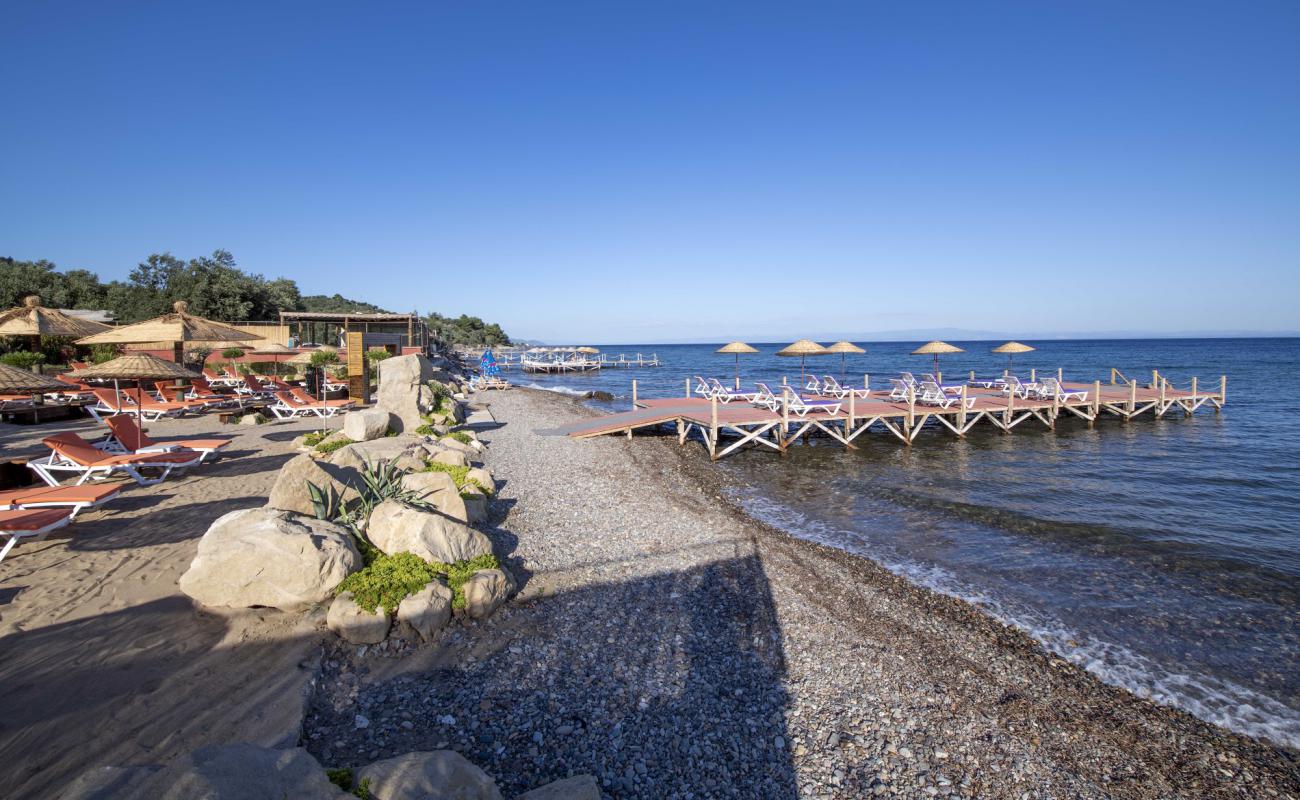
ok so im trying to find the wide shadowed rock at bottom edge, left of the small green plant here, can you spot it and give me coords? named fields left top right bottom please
left=135, top=743, right=351, bottom=800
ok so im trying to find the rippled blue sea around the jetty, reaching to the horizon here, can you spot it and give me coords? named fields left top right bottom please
left=508, top=340, right=1300, bottom=748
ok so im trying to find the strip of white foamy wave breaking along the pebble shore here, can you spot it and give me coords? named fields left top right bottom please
left=728, top=489, right=1300, bottom=749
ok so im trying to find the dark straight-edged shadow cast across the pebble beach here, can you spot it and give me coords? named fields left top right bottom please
left=304, top=555, right=797, bottom=797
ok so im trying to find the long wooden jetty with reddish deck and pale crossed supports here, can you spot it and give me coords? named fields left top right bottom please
left=558, top=372, right=1227, bottom=460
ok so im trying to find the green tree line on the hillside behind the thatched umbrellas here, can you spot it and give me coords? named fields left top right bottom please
left=0, top=250, right=510, bottom=345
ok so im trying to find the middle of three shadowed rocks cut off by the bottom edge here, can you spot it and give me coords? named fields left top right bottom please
left=358, top=749, right=502, bottom=800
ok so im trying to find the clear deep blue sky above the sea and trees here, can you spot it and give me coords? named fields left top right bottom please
left=0, top=0, right=1300, bottom=342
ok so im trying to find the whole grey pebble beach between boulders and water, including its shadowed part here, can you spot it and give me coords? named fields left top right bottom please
left=303, top=389, right=1300, bottom=799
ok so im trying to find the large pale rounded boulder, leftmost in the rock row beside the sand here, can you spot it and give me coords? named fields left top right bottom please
left=181, top=507, right=361, bottom=611
